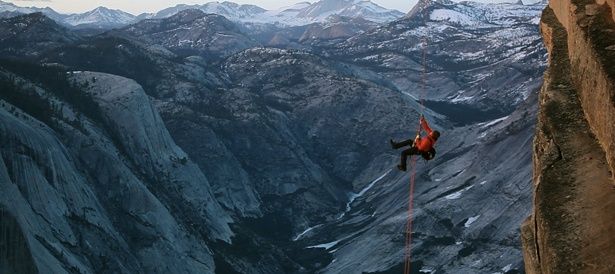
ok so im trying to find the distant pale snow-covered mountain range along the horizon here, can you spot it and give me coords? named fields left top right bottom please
left=0, top=0, right=410, bottom=29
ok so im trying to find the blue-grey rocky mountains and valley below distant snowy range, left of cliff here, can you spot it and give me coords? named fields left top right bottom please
left=0, top=0, right=546, bottom=274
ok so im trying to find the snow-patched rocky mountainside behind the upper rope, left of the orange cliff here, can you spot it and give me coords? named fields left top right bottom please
left=315, top=0, right=544, bottom=124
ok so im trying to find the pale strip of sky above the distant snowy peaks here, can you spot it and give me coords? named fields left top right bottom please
left=2, top=0, right=528, bottom=15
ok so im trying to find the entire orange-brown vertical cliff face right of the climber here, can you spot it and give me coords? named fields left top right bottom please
left=521, top=0, right=615, bottom=273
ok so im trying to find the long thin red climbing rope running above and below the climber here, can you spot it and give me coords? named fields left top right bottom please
left=404, top=0, right=431, bottom=274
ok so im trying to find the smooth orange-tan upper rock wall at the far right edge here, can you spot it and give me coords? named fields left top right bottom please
left=549, top=0, right=615, bottom=182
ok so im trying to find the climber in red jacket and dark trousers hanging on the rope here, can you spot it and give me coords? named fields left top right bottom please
left=389, top=115, right=440, bottom=171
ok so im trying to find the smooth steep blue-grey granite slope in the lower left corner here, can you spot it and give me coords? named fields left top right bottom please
left=0, top=61, right=232, bottom=273
